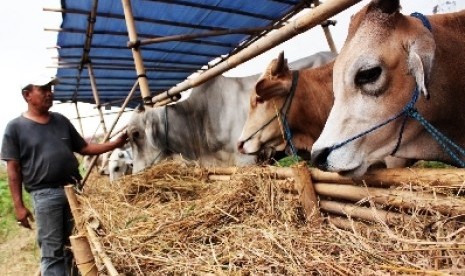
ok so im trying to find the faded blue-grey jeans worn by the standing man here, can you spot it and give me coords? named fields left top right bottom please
left=31, top=188, right=74, bottom=276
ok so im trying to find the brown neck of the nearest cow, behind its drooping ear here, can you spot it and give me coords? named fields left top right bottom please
left=417, top=11, right=465, bottom=147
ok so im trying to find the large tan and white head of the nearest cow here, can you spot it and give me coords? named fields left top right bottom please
left=312, top=0, right=435, bottom=176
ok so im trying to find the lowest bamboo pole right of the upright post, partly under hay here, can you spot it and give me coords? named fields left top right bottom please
left=320, top=200, right=412, bottom=225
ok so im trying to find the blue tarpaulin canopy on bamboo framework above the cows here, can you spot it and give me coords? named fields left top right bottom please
left=55, top=0, right=313, bottom=107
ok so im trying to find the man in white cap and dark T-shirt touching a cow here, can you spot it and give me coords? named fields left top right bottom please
left=1, top=74, right=128, bottom=276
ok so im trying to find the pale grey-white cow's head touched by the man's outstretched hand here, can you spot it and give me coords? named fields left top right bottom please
left=127, top=105, right=169, bottom=173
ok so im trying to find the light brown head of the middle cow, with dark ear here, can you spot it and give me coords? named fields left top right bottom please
left=238, top=52, right=292, bottom=154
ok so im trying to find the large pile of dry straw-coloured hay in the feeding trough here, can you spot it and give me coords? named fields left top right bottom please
left=79, top=161, right=465, bottom=275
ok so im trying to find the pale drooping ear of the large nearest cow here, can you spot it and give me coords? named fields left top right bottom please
left=408, top=33, right=436, bottom=99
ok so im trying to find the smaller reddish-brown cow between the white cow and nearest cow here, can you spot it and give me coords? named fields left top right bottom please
left=238, top=53, right=410, bottom=167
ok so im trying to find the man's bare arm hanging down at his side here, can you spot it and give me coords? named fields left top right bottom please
left=6, top=160, right=34, bottom=229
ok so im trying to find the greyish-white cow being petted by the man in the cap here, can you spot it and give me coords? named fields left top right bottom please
left=127, top=52, right=334, bottom=173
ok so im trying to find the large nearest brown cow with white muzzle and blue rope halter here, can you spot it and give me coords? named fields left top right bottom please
left=312, top=0, right=465, bottom=176
